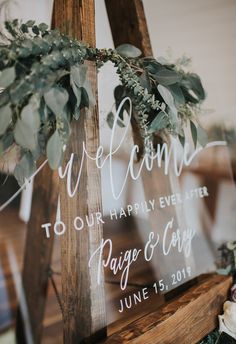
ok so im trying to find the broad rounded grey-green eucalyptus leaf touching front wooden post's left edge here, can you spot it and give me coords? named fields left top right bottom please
left=44, top=87, right=69, bottom=116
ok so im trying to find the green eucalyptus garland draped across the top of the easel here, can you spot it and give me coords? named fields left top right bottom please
left=0, top=20, right=207, bottom=184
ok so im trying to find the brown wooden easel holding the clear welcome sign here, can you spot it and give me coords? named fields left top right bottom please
left=17, top=0, right=231, bottom=344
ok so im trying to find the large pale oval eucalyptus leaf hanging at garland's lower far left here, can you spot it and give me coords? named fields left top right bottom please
left=14, top=104, right=40, bottom=151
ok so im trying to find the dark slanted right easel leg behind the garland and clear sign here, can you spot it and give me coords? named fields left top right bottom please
left=105, top=0, right=194, bottom=290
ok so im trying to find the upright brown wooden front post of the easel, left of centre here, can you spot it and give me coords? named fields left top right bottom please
left=53, top=0, right=106, bottom=344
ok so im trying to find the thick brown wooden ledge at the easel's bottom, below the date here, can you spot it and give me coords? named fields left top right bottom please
left=103, top=275, right=232, bottom=344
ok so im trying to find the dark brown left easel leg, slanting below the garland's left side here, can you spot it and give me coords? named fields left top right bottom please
left=16, top=166, right=58, bottom=343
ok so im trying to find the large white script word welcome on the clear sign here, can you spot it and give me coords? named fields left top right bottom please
left=59, top=97, right=227, bottom=199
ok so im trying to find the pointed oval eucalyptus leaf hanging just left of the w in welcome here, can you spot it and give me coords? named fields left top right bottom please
left=47, top=130, right=63, bottom=170
